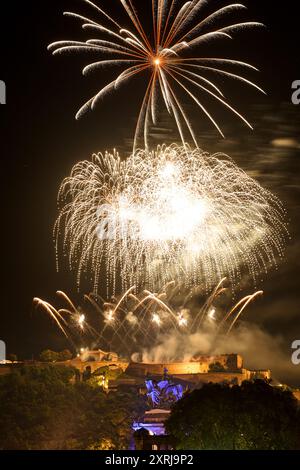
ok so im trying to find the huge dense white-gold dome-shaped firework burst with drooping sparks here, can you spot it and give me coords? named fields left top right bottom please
left=55, top=144, right=287, bottom=296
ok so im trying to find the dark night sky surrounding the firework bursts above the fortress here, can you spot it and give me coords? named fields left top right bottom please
left=0, top=0, right=300, bottom=382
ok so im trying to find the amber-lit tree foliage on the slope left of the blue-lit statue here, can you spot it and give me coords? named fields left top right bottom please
left=0, top=365, right=145, bottom=450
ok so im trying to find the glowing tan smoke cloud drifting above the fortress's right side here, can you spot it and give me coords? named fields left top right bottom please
left=132, top=323, right=300, bottom=386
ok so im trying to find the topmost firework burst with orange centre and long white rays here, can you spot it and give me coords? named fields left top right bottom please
left=49, top=0, right=263, bottom=149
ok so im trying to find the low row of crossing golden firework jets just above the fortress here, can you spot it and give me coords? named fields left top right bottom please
left=34, top=278, right=263, bottom=353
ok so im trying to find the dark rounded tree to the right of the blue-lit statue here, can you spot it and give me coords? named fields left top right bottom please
left=166, top=380, right=300, bottom=450
